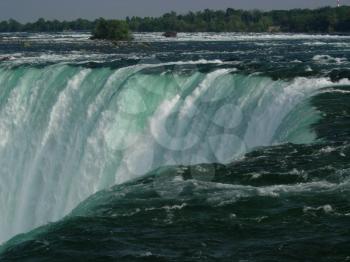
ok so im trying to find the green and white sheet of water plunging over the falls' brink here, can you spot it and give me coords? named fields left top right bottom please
left=0, top=60, right=346, bottom=241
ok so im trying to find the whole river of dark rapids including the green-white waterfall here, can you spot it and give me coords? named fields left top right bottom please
left=0, top=33, right=350, bottom=261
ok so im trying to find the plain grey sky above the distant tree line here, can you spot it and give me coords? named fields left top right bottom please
left=0, top=0, right=350, bottom=22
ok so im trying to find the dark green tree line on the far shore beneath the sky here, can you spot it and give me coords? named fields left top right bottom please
left=0, top=6, right=350, bottom=33
